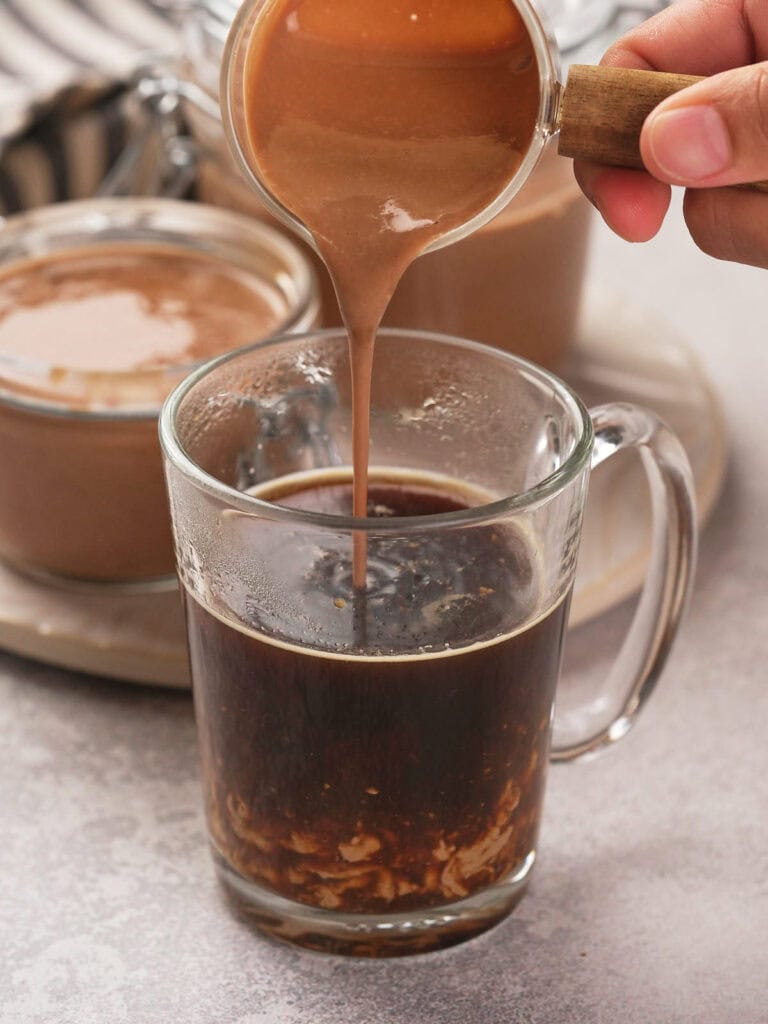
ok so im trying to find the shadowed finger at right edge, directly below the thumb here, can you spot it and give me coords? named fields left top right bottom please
left=683, top=188, right=768, bottom=269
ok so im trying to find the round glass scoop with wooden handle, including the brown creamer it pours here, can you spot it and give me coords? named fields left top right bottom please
left=221, top=0, right=765, bottom=588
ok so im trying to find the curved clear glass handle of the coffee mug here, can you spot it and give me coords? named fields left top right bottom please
left=551, top=402, right=697, bottom=761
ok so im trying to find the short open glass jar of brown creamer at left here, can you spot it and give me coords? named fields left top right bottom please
left=0, top=199, right=318, bottom=586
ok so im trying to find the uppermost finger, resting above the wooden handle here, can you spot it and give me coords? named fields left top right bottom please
left=601, top=0, right=768, bottom=76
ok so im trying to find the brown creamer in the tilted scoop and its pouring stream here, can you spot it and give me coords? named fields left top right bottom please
left=243, top=0, right=540, bottom=587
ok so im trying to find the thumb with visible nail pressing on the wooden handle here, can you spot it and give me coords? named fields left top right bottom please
left=640, top=61, right=768, bottom=188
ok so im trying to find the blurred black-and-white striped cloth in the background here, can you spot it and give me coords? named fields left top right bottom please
left=0, top=0, right=178, bottom=213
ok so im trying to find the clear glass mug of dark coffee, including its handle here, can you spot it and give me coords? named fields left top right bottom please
left=161, top=331, right=695, bottom=956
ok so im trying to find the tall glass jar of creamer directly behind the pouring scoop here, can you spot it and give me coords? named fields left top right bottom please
left=176, top=0, right=592, bottom=368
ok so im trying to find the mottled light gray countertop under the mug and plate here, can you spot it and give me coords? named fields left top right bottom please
left=0, top=199, right=768, bottom=1024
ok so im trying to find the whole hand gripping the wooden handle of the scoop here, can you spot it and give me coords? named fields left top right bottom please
left=574, top=0, right=768, bottom=268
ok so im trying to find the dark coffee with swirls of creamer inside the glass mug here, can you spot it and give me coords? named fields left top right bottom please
left=185, top=471, right=568, bottom=912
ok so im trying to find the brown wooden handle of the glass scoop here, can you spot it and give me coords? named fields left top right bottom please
left=557, top=65, right=768, bottom=191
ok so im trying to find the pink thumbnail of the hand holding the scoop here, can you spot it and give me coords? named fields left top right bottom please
left=646, top=104, right=733, bottom=182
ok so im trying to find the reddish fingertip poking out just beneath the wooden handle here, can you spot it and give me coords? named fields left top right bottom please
left=573, top=161, right=672, bottom=242
